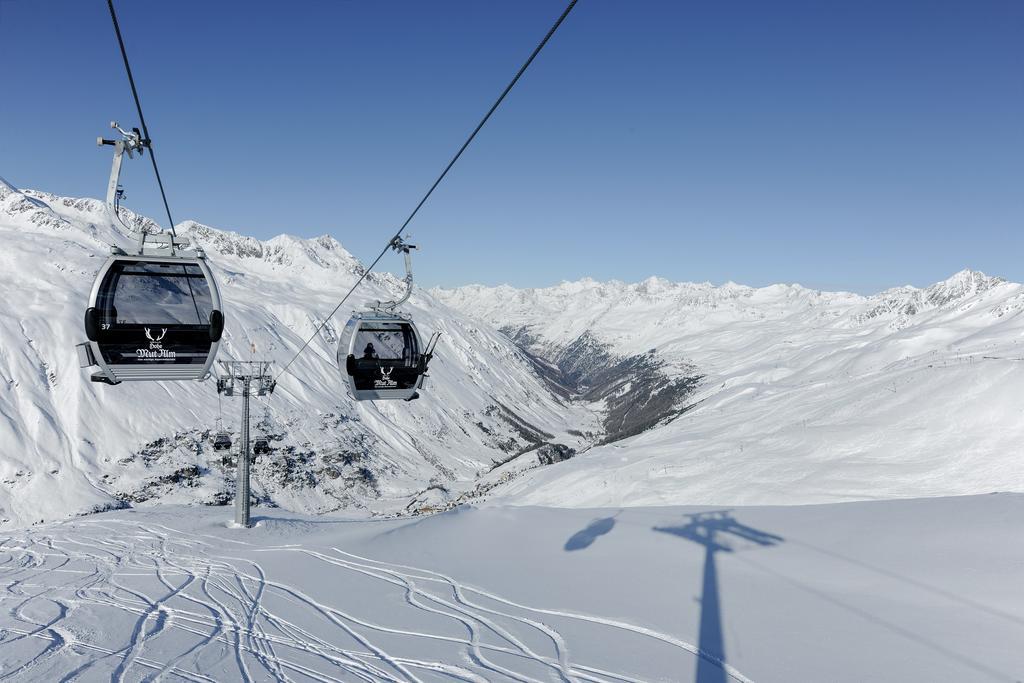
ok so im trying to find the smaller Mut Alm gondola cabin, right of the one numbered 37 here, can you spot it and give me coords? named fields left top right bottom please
left=338, top=310, right=429, bottom=400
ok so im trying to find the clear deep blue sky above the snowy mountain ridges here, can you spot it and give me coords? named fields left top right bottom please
left=0, top=0, right=1024, bottom=293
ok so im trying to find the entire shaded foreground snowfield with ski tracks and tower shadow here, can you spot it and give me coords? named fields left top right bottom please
left=0, top=494, right=1024, bottom=683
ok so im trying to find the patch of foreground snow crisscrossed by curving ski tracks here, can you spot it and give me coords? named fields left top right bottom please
left=0, top=519, right=737, bottom=683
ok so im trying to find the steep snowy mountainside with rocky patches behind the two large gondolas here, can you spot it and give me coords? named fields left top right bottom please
left=0, top=182, right=596, bottom=524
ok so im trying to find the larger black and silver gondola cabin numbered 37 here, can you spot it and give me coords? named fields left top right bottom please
left=80, top=252, right=224, bottom=384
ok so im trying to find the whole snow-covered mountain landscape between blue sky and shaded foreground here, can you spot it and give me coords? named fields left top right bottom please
left=8, top=176, right=1024, bottom=524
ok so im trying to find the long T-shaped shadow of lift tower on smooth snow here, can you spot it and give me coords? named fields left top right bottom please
left=654, top=510, right=784, bottom=683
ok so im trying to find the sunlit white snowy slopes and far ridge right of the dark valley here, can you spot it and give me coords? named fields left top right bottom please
left=433, top=270, right=1024, bottom=506
